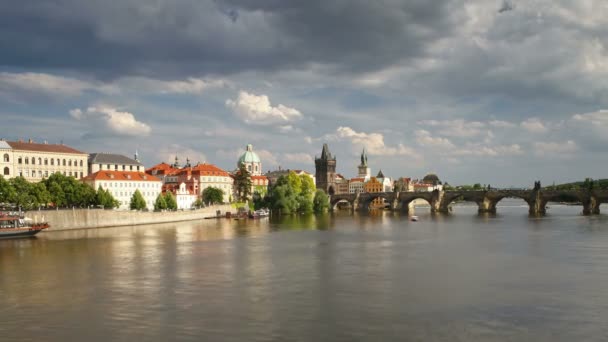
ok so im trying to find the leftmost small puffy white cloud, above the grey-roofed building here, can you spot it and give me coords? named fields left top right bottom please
left=70, top=106, right=152, bottom=137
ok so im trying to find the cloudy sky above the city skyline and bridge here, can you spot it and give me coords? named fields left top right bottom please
left=0, top=0, right=608, bottom=187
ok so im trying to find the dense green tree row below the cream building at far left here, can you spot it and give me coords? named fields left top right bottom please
left=0, top=173, right=118, bottom=210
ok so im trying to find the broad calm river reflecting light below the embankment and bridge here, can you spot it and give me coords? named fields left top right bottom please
left=0, top=201, right=608, bottom=341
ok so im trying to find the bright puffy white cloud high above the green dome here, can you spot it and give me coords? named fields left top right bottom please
left=226, top=91, right=302, bottom=127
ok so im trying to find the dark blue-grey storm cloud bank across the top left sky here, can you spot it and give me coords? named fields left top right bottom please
left=0, top=0, right=455, bottom=78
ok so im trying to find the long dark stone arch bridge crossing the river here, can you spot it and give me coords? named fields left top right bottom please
left=329, top=188, right=608, bottom=215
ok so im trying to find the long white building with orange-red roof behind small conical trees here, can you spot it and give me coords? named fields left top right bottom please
left=82, top=170, right=163, bottom=210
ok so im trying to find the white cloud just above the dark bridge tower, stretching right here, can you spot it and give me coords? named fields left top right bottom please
left=328, top=126, right=417, bottom=157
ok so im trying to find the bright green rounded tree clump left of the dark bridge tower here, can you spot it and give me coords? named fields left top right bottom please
left=254, top=171, right=328, bottom=214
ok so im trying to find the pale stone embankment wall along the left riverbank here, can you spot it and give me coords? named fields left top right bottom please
left=26, top=205, right=236, bottom=230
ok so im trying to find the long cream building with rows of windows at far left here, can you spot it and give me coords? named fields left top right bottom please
left=0, top=140, right=88, bottom=182
